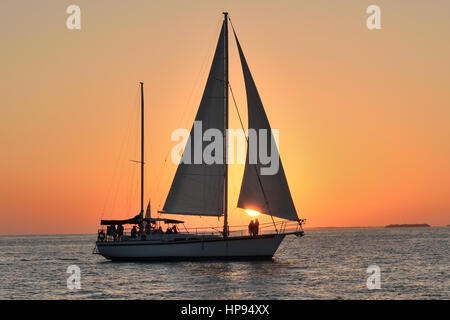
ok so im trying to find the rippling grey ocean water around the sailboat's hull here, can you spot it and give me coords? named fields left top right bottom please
left=0, top=227, right=450, bottom=299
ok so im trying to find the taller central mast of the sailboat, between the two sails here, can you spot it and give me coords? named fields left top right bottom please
left=223, top=12, right=228, bottom=238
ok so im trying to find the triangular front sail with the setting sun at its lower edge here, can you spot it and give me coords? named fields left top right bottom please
left=233, top=29, right=298, bottom=221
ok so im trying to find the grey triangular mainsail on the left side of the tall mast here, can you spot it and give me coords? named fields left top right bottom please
left=161, top=20, right=228, bottom=216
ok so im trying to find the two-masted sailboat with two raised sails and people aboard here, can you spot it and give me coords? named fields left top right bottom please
left=94, top=12, right=305, bottom=261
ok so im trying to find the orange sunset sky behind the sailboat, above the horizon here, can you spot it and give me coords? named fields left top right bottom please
left=0, top=0, right=450, bottom=234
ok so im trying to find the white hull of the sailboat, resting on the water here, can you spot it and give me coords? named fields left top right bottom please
left=97, top=234, right=286, bottom=261
